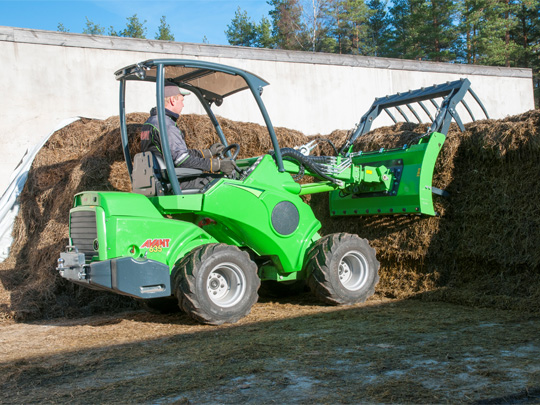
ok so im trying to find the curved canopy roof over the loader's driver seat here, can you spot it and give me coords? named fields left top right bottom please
left=115, top=59, right=268, bottom=105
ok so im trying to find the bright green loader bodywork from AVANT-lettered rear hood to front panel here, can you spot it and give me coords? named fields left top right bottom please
left=68, top=155, right=321, bottom=279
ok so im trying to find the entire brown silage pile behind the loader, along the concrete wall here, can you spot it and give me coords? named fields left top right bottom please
left=0, top=110, right=540, bottom=319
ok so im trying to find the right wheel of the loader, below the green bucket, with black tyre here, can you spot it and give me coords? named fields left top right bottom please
left=308, top=233, right=379, bottom=305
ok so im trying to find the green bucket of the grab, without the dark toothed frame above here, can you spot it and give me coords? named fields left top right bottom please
left=330, top=132, right=446, bottom=216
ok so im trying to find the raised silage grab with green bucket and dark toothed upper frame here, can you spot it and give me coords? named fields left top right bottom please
left=320, top=79, right=489, bottom=216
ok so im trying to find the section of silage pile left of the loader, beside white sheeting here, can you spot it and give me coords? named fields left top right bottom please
left=0, top=114, right=148, bottom=319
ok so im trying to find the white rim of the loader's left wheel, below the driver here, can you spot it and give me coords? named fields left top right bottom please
left=206, top=263, right=246, bottom=308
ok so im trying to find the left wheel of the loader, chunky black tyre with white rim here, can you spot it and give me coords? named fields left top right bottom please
left=175, top=244, right=261, bottom=325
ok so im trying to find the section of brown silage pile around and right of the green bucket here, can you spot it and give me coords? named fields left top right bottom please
left=318, top=110, right=540, bottom=311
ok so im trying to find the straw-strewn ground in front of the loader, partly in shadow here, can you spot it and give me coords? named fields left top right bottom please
left=0, top=293, right=540, bottom=404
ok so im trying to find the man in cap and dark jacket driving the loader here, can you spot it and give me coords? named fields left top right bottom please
left=141, top=82, right=234, bottom=189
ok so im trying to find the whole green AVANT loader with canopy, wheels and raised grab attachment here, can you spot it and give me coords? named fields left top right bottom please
left=57, top=59, right=487, bottom=324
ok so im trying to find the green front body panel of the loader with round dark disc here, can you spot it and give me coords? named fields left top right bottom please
left=153, top=155, right=321, bottom=278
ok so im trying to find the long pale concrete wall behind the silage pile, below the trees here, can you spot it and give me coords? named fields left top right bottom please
left=0, top=26, right=534, bottom=195
